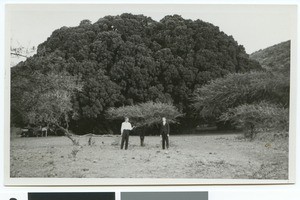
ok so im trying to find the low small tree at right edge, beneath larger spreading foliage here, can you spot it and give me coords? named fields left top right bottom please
left=220, top=102, right=289, bottom=139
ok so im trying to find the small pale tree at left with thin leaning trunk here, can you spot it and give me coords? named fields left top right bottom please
left=21, top=72, right=81, bottom=144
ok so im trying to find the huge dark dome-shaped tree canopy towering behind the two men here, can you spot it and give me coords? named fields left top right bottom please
left=12, top=13, right=261, bottom=134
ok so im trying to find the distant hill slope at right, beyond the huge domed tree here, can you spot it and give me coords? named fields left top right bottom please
left=250, top=40, right=291, bottom=71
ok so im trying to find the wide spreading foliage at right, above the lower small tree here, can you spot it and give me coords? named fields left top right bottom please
left=194, top=72, right=289, bottom=118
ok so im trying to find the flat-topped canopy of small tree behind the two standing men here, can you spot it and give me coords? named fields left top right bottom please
left=107, top=102, right=183, bottom=127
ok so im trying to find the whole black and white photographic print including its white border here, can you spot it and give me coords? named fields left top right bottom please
left=5, top=4, right=297, bottom=185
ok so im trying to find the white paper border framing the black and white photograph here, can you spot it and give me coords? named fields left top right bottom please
left=4, top=3, right=298, bottom=186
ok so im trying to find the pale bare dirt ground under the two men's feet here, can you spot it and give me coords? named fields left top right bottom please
left=10, top=134, right=288, bottom=179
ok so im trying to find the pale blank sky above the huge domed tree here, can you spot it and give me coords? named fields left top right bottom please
left=6, top=4, right=296, bottom=65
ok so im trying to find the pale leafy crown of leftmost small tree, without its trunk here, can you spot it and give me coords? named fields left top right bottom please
left=25, top=74, right=81, bottom=125
